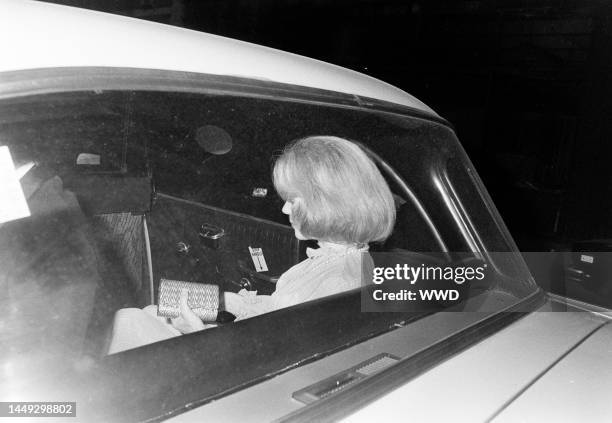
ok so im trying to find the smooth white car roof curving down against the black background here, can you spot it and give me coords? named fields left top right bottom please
left=0, top=0, right=437, bottom=116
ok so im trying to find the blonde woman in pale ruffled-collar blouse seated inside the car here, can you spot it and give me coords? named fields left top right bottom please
left=110, top=136, right=395, bottom=352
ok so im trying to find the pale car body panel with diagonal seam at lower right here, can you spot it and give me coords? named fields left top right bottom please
left=346, top=305, right=612, bottom=422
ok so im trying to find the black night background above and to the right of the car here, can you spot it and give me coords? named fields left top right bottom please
left=44, top=0, right=612, bottom=251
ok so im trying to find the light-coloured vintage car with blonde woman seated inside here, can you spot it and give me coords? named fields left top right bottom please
left=0, top=0, right=612, bottom=422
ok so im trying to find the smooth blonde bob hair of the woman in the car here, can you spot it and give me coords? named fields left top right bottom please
left=273, top=136, right=395, bottom=245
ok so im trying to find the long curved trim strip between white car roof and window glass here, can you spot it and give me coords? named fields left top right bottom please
left=0, top=66, right=454, bottom=127
